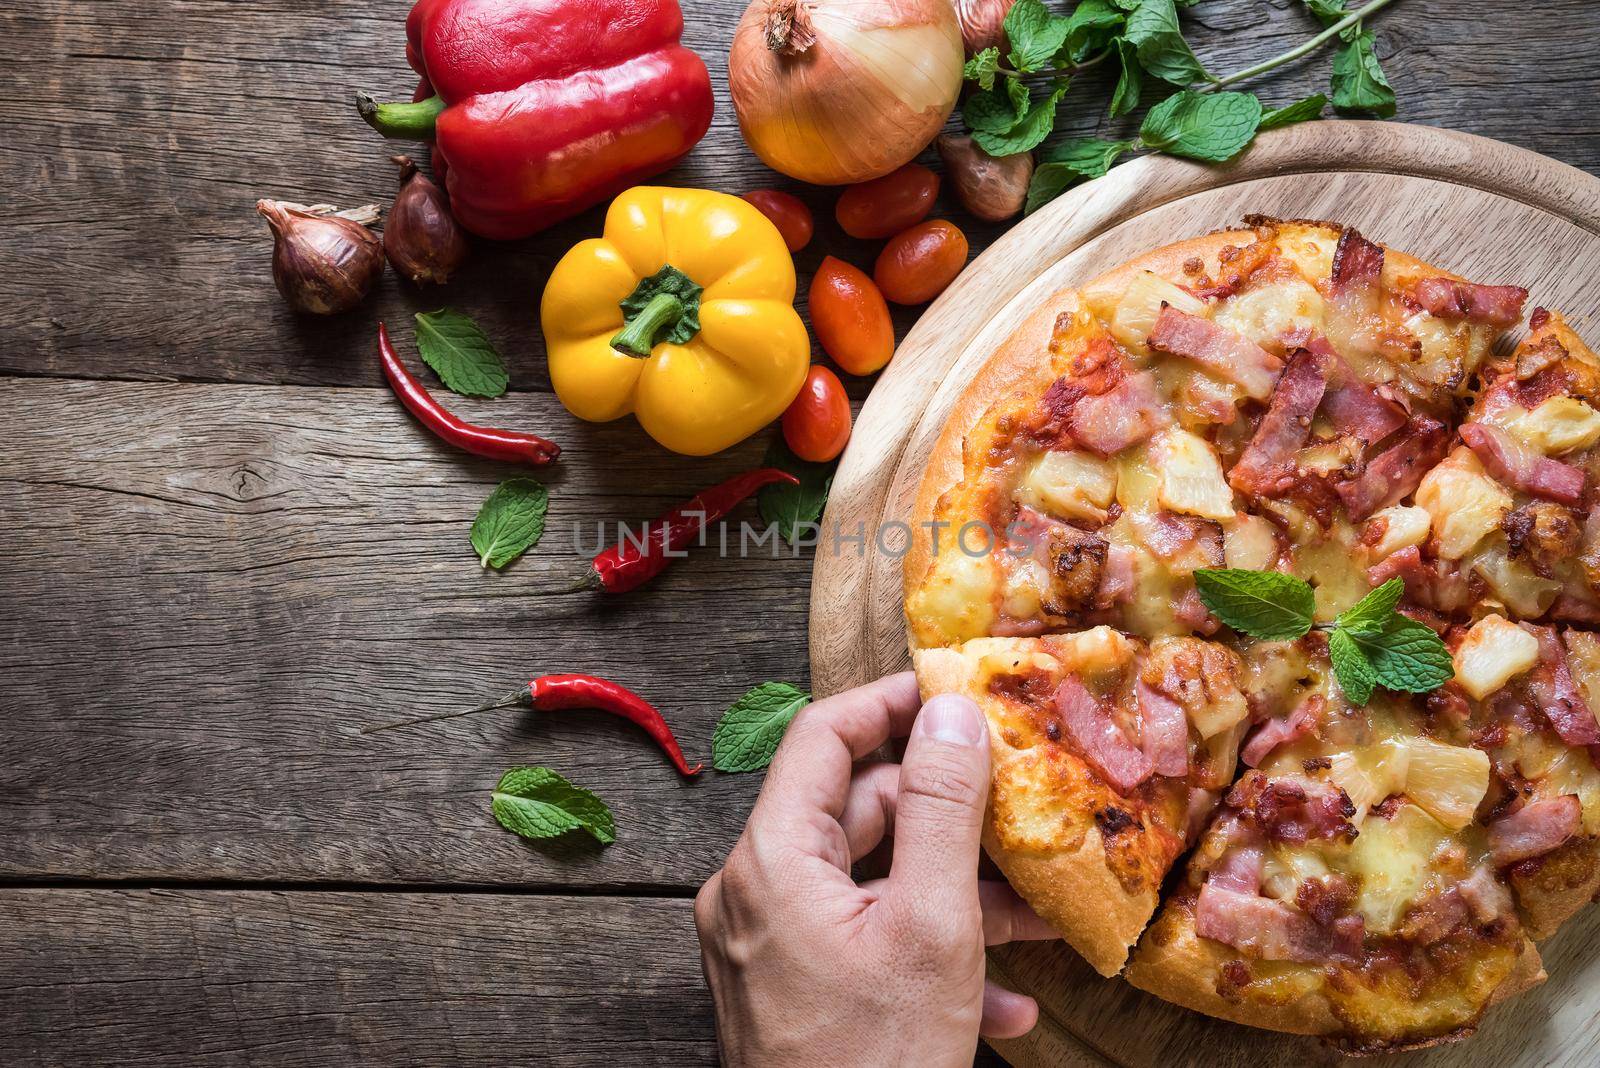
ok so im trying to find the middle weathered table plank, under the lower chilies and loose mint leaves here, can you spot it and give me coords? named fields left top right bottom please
left=0, top=379, right=810, bottom=891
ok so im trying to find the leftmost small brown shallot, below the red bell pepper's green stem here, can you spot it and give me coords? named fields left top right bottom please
left=256, top=200, right=384, bottom=315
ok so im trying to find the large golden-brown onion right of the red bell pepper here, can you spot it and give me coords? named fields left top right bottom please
left=728, top=0, right=963, bottom=185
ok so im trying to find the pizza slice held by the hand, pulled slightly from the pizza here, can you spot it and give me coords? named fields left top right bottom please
left=914, top=627, right=1250, bottom=975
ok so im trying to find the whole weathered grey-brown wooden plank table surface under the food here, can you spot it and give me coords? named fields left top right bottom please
left=0, top=0, right=1600, bottom=1066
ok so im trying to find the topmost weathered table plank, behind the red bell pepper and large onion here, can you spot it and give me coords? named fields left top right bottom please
left=0, top=0, right=1600, bottom=388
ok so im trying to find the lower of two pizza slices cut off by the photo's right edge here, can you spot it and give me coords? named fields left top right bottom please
left=1430, top=616, right=1600, bottom=938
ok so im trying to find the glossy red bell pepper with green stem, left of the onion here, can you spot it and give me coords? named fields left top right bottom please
left=357, top=0, right=712, bottom=240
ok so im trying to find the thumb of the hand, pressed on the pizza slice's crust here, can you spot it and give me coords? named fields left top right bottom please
left=888, top=694, right=989, bottom=916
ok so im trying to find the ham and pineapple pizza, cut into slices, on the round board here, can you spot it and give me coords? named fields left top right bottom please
left=906, top=217, right=1600, bottom=1052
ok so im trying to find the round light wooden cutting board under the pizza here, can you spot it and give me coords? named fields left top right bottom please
left=811, top=122, right=1600, bottom=1068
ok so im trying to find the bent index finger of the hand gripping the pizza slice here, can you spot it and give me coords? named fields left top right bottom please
left=750, top=671, right=920, bottom=830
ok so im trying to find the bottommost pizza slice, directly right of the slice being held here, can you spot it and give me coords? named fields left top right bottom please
left=1126, top=660, right=1544, bottom=1052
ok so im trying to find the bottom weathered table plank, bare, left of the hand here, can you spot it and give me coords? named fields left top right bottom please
left=0, top=891, right=717, bottom=1068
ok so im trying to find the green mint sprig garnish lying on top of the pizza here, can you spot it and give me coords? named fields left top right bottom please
left=1195, top=568, right=1454, bottom=705
